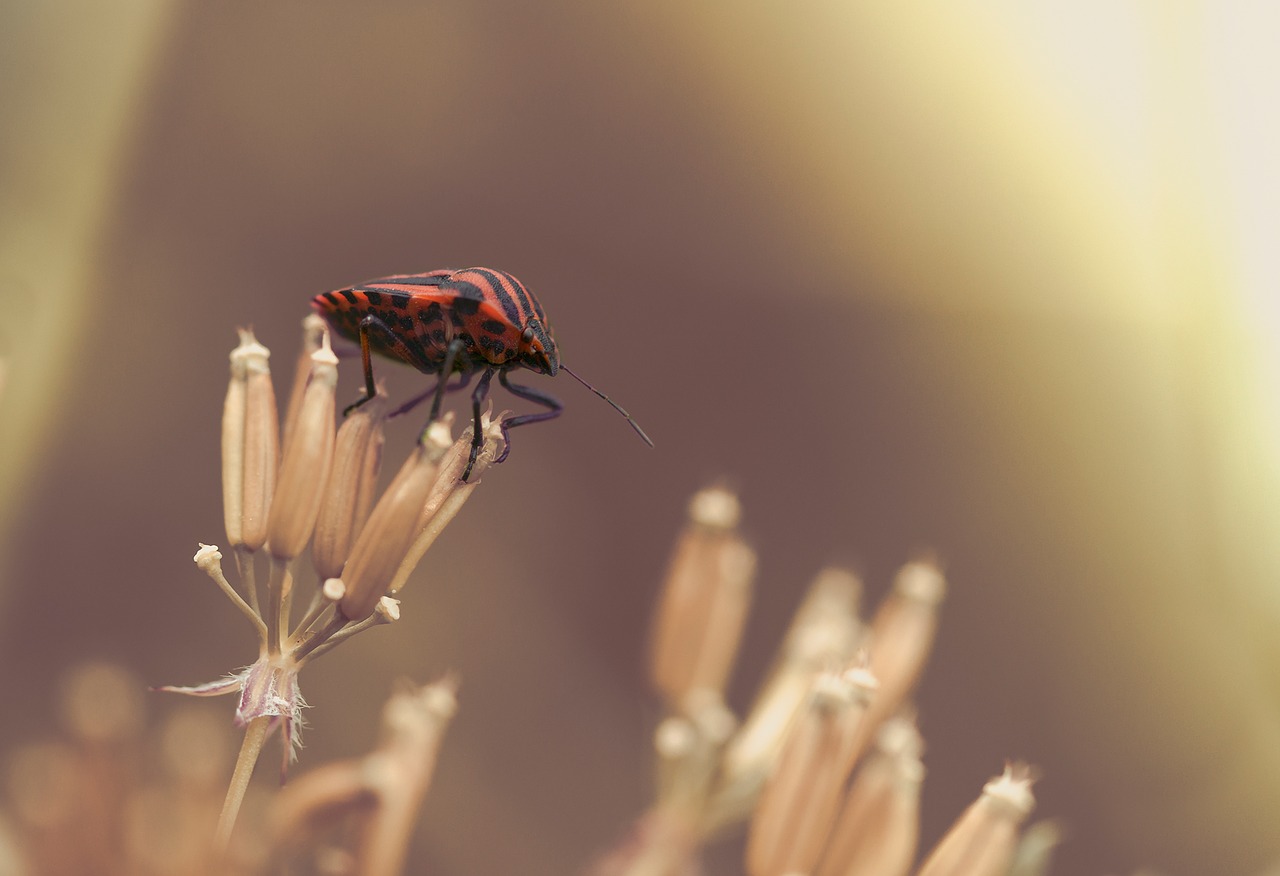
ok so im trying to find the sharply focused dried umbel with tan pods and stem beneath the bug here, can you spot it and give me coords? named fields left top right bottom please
left=160, top=315, right=507, bottom=849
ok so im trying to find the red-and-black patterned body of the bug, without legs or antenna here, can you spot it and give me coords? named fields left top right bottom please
left=311, top=268, right=559, bottom=375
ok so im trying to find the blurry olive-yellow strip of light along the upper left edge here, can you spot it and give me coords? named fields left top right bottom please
left=0, top=0, right=170, bottom=581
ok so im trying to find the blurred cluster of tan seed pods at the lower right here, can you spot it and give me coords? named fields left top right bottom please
left=589, top=487, right=1047, bottom=876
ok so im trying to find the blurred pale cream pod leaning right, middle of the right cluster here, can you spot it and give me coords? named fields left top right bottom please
left=718, top=567, right=864, bottom=821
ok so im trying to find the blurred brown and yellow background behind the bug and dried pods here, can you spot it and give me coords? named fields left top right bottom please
left=0, top=0, right=1280, bottom=875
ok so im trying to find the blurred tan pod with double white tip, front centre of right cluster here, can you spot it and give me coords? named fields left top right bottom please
left=746, top=669, right=876, bottom=876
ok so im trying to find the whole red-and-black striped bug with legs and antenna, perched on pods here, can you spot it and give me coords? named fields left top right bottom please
left=311, top=268, right=653, bottom=480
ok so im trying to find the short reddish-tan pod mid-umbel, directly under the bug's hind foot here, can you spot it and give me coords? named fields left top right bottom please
left=311, top=393, right=387, bottom=580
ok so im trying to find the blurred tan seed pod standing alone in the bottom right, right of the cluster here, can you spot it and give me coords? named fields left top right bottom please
left=919, top=763, right=1036, bottom=876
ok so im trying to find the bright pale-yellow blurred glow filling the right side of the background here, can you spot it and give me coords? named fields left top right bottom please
left=640, top=0, right=1280, bottom=870
